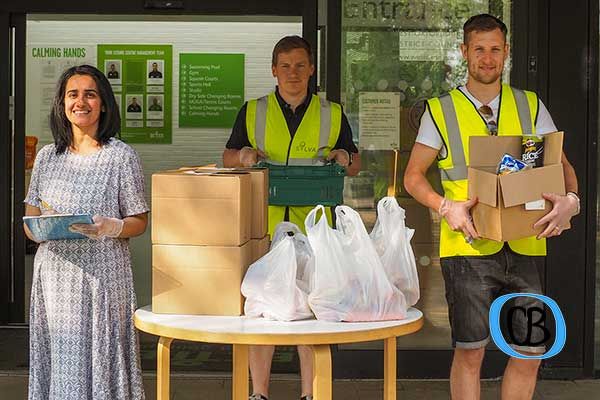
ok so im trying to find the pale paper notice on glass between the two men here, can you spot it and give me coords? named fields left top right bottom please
left=358, top=92, right=400, bottom=150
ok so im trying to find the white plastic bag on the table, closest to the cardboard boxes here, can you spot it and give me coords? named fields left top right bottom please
left=241, top=223, right=313, bottom=321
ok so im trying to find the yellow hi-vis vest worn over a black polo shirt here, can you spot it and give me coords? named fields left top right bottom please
left=246, top=92, right=342, bottom=237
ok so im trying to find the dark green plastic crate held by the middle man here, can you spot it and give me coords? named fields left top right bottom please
left=258, top=162, right=346, bottom=206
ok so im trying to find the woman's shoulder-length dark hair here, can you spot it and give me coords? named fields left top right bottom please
left=50, top=65, right=121, bottom=154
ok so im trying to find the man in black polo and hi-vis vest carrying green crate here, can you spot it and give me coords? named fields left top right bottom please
left=223, top=36, right=360, bottom=400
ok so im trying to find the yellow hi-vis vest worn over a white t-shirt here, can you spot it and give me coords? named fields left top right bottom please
left=427, top=85, right=546, bottom=257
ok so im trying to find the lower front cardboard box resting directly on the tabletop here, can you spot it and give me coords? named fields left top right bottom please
left=152, top=242, right=253, bottom=315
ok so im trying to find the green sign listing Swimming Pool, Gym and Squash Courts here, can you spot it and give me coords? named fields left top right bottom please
left=179, top=53, right=244, bottom=128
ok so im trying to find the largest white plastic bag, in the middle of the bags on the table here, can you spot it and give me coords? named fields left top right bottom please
left=305, top=206, right=406, bottom=321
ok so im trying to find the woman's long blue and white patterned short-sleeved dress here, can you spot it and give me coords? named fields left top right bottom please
left=25, top=139, right=149, bottom=400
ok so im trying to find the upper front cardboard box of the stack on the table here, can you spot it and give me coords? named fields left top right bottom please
left=152, top=171, right=251, bottom=246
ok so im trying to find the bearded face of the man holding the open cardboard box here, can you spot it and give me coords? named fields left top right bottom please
left=460, top=29, right=508, bottom=84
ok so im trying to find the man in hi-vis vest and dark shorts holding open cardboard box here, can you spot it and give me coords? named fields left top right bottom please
left=404, top=14, right=579, bottom=400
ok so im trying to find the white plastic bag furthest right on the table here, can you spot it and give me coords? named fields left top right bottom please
left=370, top=197, right=420, bottom=306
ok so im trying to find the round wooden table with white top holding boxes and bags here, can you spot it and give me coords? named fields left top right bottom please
left=134, top=306, right=423, bottom=400
